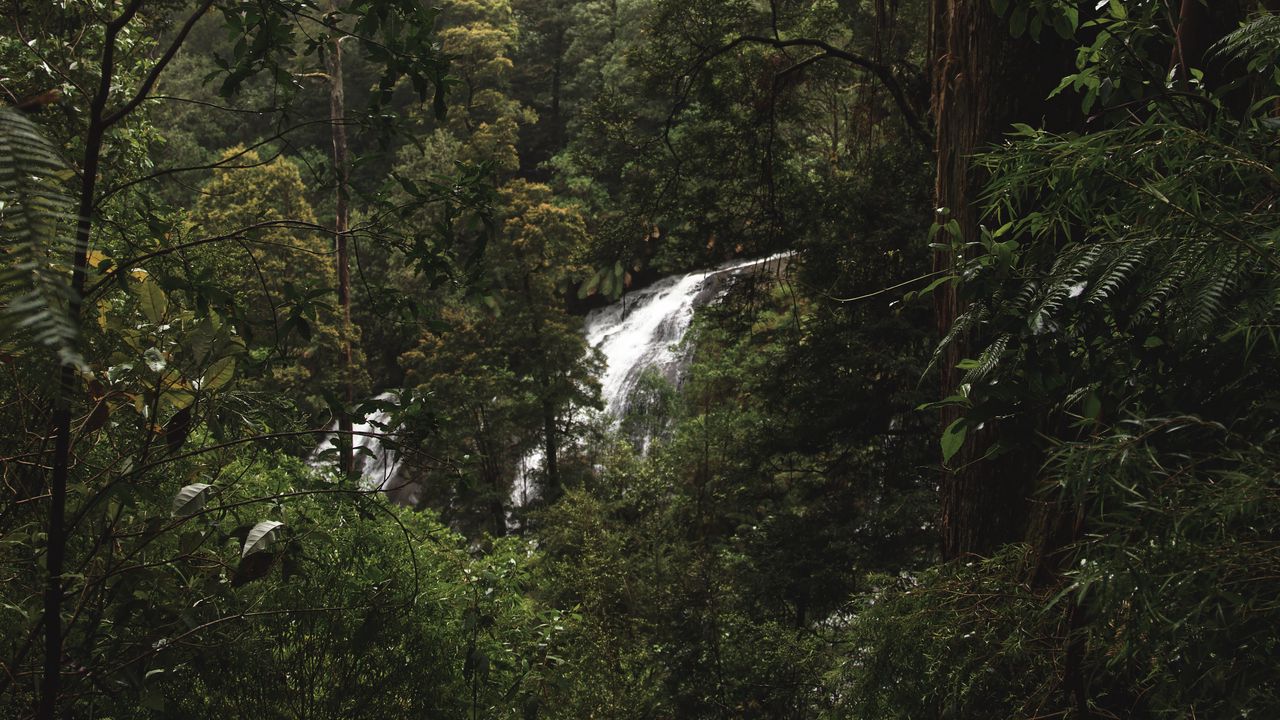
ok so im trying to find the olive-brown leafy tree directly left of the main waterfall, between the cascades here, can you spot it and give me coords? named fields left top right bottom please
left=401, top=181, right=598, bottom=534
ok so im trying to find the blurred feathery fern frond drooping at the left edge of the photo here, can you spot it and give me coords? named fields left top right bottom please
left=0, top=109, right=84, bottom=368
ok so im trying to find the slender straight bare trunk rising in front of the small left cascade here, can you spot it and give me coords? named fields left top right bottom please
left=325, top=19, right=356, bottom=473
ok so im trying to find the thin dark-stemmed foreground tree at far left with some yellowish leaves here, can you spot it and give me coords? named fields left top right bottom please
left=4, top=0, right=443, bottom=719
